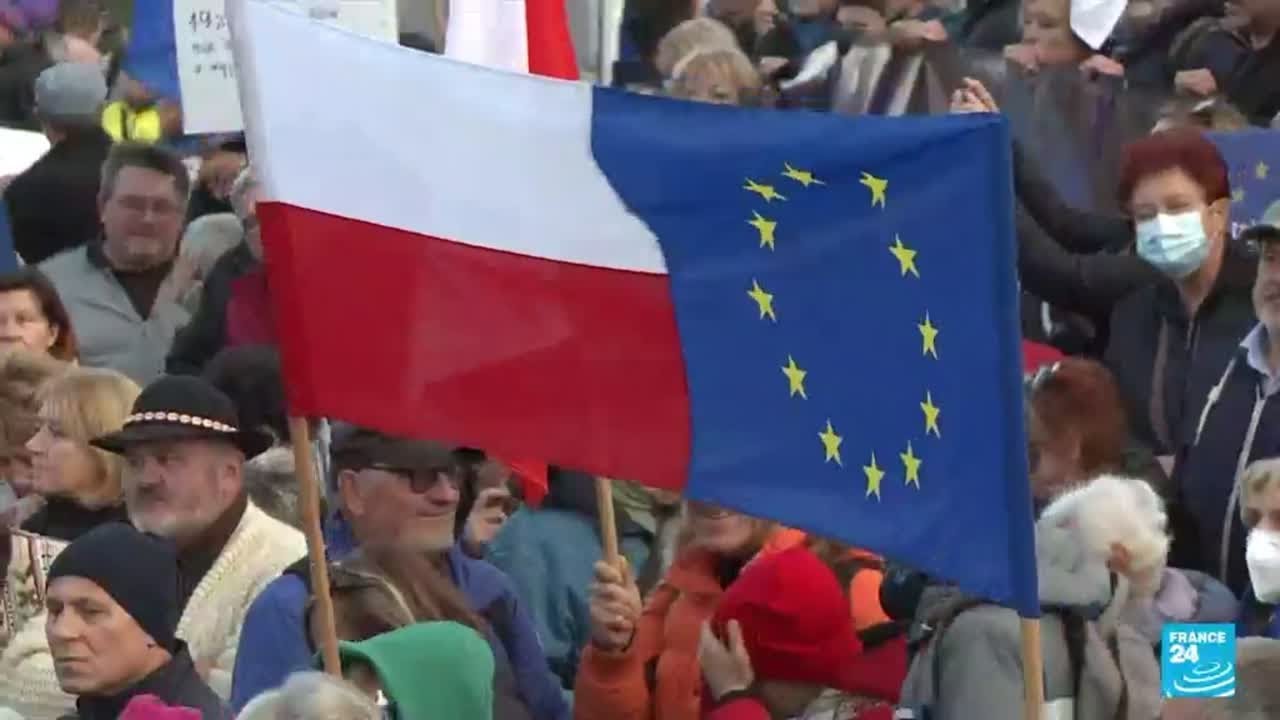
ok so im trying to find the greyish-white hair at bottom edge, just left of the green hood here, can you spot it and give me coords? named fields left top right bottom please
left=236, top=671, right=383, bottom=720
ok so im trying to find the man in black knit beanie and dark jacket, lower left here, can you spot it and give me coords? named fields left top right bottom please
left=45, top=523, right=230, bottom=720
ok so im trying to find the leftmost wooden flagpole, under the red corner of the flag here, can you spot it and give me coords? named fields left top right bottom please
left=289, top=416, right=342, bottom=678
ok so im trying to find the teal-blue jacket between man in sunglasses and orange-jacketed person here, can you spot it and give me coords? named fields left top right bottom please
left=489, top=473, right=653, bottom=689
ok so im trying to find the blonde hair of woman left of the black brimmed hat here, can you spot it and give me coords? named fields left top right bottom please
left=36, top=368, right=142, bottom=507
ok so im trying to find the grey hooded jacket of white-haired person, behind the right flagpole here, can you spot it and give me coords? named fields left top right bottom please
left=901, top=512, right=1160, bottom=720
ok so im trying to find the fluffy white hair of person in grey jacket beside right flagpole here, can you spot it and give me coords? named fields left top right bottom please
left=1042, top=475, right=1169, bottom=597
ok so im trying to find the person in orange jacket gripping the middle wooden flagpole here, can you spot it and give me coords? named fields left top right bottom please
left=573, top=502, right=780, bottom=720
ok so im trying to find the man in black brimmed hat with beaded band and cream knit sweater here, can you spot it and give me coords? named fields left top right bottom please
left=93, top=377, right=306, bottom=697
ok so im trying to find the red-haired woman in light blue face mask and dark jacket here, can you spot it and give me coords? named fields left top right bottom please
left=1106, top=128, right=1256, bottom=465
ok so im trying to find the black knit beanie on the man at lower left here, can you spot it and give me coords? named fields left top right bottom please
left=49, top=523, right=182, bottom=652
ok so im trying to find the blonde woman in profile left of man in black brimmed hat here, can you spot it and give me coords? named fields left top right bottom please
left=23, top=368, right=141, bottom=542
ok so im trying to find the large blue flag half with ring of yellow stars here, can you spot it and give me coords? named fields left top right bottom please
left=591, top=91, right=1039, bottom=616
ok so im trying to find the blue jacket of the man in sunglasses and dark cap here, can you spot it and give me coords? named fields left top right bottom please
left=232, top=546, right=570, bottom=720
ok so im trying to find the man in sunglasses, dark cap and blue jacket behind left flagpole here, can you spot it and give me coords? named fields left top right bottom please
left=232, top=425, right=570, bottom=720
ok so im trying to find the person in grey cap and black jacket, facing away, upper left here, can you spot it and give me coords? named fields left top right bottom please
left=4, top=63, right=111, bottom=265
